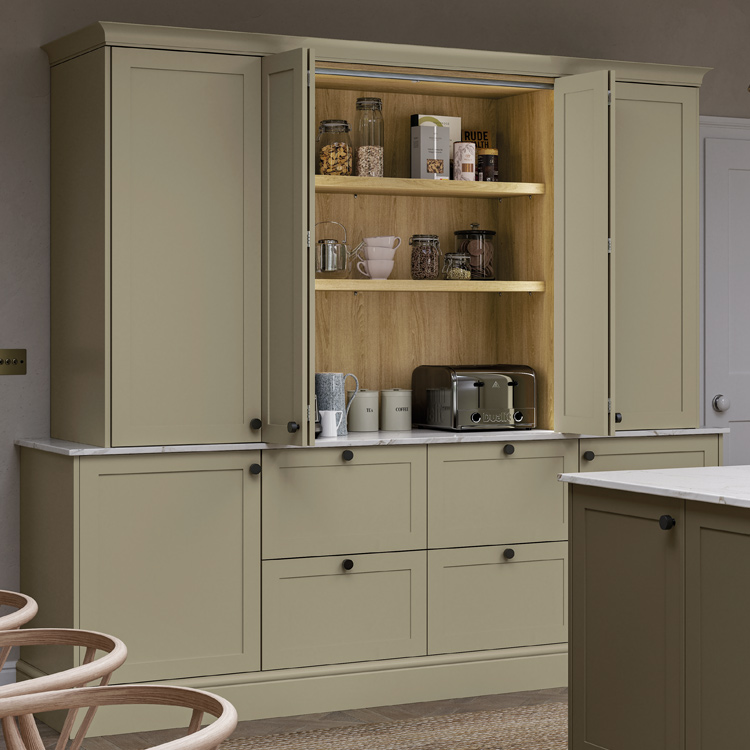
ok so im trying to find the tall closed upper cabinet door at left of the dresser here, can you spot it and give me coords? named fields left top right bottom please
left=111, top=48, right=261, bottom=446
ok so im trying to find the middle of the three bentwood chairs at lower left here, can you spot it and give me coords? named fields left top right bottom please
left=0, top=628, right=128, bottom=750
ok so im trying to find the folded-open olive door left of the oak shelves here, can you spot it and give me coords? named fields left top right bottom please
left=261, top=49, right=315, bottom=445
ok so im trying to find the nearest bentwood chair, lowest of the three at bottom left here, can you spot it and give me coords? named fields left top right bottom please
left=0, top=685, right=237, bottom=750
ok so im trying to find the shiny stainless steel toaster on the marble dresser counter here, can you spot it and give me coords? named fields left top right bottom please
left=411, top=365, right=536, bottom=430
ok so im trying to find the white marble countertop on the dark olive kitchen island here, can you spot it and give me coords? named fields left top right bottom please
left=558, top=466, right=750, bottom=508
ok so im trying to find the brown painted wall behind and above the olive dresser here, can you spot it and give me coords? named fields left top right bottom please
left=0, top=0, right=750, bottom=588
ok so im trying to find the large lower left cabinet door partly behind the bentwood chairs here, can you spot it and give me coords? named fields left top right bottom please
left=79, top=452, right=260, bottom=682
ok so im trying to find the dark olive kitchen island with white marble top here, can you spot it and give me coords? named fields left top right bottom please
left=560, top=466, right=750, bottom=750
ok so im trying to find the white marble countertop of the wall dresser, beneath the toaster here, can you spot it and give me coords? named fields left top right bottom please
left=15, top=427, right=729, bottom=456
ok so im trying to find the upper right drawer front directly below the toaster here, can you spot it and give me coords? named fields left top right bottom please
left=427, top=440, right=577, bottom=548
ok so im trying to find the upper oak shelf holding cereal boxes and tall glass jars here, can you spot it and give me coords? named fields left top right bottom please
left=315, top=175, right=545, bottom=198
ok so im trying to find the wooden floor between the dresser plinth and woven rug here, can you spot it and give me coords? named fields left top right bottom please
left=16, top=688, right=568, bottom=750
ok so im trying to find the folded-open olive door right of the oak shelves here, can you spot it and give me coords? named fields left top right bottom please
left=555, top=70, right=615, bottom=435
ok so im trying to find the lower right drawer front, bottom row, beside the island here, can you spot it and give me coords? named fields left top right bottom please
left=427, top=542, right=568, bottom=654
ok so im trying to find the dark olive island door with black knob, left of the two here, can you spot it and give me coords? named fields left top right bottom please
left=570, top=485, right=685, bottom=750
